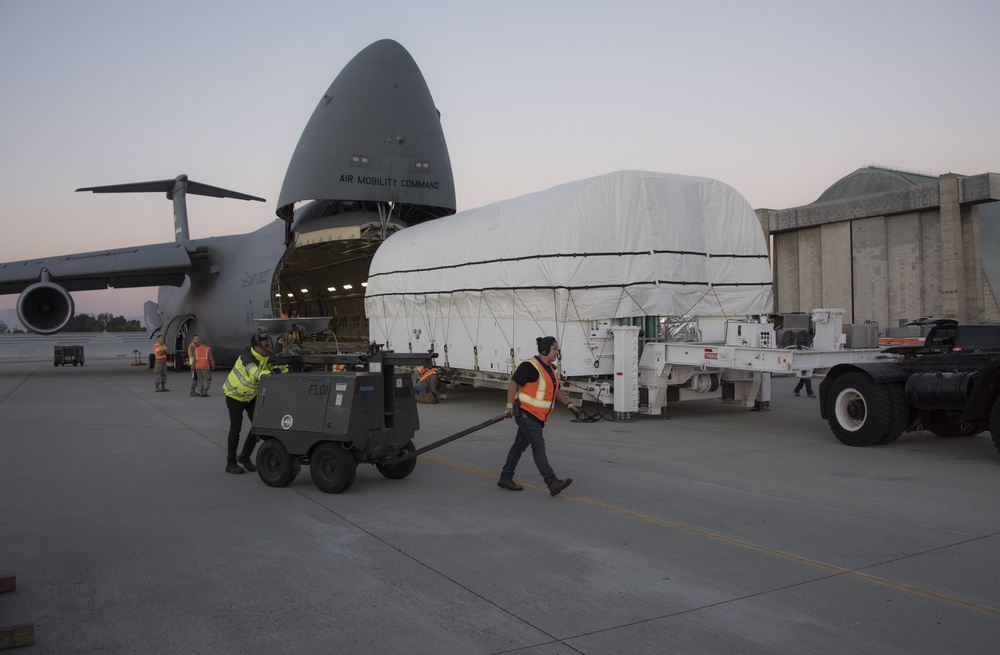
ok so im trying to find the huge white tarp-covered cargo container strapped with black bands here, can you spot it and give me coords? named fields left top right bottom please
left=365, top=171, right=772, bottom=375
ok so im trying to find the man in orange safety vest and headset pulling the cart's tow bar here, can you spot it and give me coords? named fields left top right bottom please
left=497, top=337, right=580, bottom=496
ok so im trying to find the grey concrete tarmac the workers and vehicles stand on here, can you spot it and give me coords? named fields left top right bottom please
left=0, top=358, right=1000, bottom=655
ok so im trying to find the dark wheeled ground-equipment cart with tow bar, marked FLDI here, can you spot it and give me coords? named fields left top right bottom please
left=250, top=351, right=504, bottom=494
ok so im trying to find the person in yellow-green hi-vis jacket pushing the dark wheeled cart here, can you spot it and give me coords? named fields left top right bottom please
left=222, top=334, right=275, bottom=473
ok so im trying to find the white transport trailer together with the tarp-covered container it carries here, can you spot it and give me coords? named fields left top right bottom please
left=365, top=171, right=885, bottom=418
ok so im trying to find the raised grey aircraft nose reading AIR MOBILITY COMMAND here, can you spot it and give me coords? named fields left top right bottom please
left=277, top=39, right=455, bottom=233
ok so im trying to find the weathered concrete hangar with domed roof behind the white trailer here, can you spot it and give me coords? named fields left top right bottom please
left=756, top=167, right=1000, bottom=336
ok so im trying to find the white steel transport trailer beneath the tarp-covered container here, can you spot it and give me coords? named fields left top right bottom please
left=378, top=309, right=899, bottom=420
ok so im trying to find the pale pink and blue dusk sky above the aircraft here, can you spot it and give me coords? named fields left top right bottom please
left=0, top=0, right=1000, bottom=316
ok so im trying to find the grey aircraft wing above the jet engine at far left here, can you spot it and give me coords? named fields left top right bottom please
left=0, top=242, right=193, bottom=294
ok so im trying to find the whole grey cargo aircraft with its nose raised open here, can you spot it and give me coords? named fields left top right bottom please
left=0, top=40, right=455, bottom=368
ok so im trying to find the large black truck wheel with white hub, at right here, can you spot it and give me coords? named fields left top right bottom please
left=826, top=373, right=906, bottom=446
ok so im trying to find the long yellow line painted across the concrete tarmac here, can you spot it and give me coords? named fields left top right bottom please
left=420, top=454, right=1000, bottom=616
